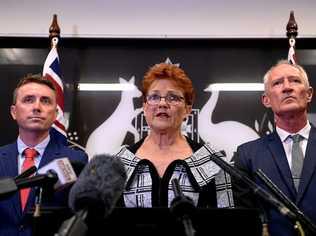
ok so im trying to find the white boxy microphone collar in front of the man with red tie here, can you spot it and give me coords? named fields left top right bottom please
left=37, top=157, right=77, bottom=190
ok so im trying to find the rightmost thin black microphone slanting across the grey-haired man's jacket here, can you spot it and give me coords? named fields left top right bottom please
left=255, top=169, right=316, bottom=235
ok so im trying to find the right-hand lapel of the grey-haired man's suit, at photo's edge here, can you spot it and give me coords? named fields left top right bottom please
left=296, top=127, right=316, bottom=204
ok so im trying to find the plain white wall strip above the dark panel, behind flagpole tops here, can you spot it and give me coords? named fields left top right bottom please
left=0, top=0, right=316, bottom=38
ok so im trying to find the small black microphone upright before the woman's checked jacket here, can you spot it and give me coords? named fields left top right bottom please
left=170, top=179, right=196, bottom=236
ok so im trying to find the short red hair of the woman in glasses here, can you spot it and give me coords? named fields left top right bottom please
left=142, top=63, right=195, bottom=105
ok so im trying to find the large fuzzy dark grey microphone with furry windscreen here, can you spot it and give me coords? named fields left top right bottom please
left=56, top=155, right=127, bottom=236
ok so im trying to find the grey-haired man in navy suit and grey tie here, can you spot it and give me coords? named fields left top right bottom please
left=232, top=61, right=316, bottom=236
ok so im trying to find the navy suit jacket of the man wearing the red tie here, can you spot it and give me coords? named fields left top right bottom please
left=0, top=138, right=88, bottom=236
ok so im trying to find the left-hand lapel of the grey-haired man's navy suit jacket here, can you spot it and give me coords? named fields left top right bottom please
left=268, top=132, right=296, bottom=199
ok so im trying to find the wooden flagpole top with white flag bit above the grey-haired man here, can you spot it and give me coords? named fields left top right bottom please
left=286, top=11, right=298, bottom=64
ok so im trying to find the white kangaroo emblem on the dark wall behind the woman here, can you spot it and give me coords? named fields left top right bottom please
left=86, top=76, right=142, bottom=158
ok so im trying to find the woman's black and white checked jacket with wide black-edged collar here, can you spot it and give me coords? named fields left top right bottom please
left=116, top=138, right=234, bottom=208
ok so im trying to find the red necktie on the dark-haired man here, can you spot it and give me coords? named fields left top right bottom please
left=20, top=148, right=38, bottom=211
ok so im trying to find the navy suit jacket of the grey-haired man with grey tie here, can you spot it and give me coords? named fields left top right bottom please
left=232, top=127, right=316, bottom=236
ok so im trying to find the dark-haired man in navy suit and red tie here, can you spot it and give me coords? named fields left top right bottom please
left=0, top=76, right=88, bottom=236
